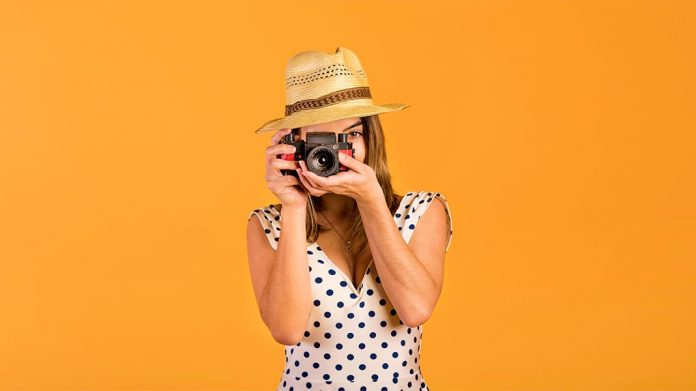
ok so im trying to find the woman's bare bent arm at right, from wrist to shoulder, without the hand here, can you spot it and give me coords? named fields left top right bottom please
left=356, top=188, right=449, bottom=327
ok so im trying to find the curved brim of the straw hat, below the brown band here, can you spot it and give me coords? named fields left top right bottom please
left=254, top=103, right=410, bottom=134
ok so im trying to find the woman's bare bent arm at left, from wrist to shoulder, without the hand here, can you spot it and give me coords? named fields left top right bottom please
left=247, top=206, right=311, bottom=345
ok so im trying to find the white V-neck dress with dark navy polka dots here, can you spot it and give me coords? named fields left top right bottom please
left=249, top=191, right=452, bottom=391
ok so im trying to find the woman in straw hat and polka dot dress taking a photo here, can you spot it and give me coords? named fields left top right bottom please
left=247, top=47, right=452, bottom=391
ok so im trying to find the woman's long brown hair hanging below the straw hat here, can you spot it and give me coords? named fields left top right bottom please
left=272, top=114, right=403, bottom=254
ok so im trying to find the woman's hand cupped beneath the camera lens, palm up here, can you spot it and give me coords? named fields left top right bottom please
left=300, top=152, right=384, bottom=202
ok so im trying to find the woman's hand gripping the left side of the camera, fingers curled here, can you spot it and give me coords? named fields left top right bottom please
left=266, top=128, right=307, bottom=207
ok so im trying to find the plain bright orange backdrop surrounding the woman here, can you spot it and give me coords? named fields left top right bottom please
left=0, top=1, right=696, bottom=391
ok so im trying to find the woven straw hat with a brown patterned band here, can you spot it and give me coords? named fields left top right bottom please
left=254, top=46, right=410, bottom=134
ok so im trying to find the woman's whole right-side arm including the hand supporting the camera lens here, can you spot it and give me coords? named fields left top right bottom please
left=303, top=153, right=450, bottom=327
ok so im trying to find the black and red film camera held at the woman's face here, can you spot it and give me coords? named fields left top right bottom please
left=280, top=130, right=355, bottom=177
